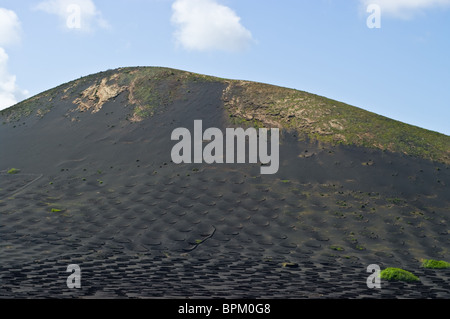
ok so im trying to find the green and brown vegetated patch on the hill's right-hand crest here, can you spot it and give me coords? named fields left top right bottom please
left=224, top=81, right=450, bottom=163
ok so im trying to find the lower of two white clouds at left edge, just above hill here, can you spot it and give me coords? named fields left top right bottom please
left=0, top=48, right=28, bottom=110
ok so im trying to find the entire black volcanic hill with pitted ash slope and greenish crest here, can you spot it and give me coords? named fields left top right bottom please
left=0, top=68, right=450, bottom=297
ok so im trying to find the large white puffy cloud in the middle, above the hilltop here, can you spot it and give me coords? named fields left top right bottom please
left=172, top=0, right=253, bottom=51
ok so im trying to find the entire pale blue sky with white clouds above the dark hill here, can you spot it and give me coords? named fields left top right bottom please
left=0, top=0, right=450, bottom=135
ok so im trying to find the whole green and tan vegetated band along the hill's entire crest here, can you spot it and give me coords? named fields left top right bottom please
left=0, top=67, right=450, bottom=164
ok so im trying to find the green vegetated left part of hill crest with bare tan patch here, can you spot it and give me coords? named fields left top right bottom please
left=0, top=67, right=219, bottom=123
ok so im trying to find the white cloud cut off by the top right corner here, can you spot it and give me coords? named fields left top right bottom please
left=360, top=0, right=450, bottom=18
